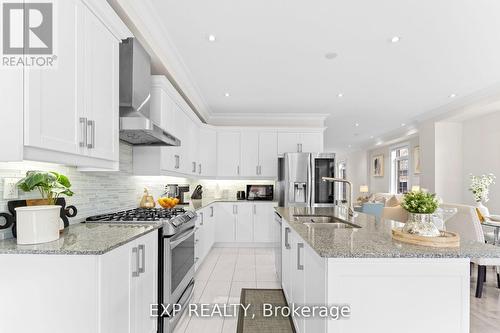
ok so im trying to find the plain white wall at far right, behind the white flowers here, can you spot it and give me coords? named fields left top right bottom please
left=462, top=111, right=500, bottom=214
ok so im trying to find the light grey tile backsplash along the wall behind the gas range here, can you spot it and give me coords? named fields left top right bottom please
left=0, top=143, right=274, bottom=239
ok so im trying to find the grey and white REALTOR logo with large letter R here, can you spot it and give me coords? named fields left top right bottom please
left=2, top=2, right=57, bottom=67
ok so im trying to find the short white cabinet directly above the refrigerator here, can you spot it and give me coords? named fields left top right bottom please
left=278, top=131, right=323, bottom=155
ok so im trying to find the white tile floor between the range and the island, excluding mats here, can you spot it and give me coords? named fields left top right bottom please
left=174, top=248, right=281, bottom=333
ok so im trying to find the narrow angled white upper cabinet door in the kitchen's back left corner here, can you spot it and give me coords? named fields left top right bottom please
left=198, top=127, right=217, bottom=177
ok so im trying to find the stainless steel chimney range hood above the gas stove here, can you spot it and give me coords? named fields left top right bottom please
left=120, top=38, right=181, bottom=146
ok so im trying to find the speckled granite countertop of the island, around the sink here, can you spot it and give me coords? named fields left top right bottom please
left=275, top=207, right=500, bottom=258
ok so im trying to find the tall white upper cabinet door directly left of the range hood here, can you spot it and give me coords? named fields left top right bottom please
left=85, top=10, right=120, bottom=161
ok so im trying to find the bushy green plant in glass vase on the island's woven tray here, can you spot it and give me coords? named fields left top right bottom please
left=401, top=191, right=440, bottom=237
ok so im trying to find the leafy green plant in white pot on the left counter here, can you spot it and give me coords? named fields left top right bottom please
left=16, top=171, right=73, bottom=244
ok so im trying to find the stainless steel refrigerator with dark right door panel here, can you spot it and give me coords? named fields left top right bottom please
left=277, top=153, right=335, bottom=207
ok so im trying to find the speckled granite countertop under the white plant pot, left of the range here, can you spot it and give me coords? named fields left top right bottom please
left=0, top=222, right=162, bottom=255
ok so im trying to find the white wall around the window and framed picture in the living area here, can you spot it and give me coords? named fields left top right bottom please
left=367, top=136, right=420, bottom=193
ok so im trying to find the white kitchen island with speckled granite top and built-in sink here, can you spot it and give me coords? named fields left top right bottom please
left=275, top=207, right=500, bottom=333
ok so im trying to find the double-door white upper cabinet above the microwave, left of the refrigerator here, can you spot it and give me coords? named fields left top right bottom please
left=241, top=131, right=278, bottom=178
